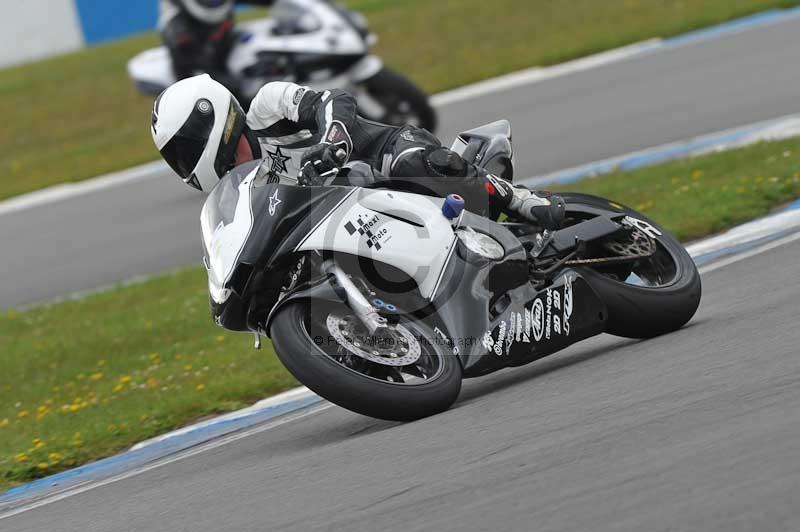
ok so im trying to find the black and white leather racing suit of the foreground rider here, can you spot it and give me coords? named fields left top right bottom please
left=246, top=82, right=511, bottom=216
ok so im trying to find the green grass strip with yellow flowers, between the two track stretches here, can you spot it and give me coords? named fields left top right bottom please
left=0, top=134, right=800, bottom=488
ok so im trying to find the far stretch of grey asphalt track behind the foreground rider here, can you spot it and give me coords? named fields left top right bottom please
left=0, top=15, right=800, bottom=308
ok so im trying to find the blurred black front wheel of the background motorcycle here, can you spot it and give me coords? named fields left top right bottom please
left=356, top=68, right=438, bottom=133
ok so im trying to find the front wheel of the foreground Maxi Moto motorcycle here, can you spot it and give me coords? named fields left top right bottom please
left=270, top=301, right=462, bottom=421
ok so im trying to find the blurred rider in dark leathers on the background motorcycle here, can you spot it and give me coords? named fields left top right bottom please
left=158, top=0, right=275, bottom=92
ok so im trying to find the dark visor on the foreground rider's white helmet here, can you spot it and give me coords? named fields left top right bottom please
left=161, top=100, right=214, bottom=189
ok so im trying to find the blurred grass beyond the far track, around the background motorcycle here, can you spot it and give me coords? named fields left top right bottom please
left=0, top=0, right=800, bottom=199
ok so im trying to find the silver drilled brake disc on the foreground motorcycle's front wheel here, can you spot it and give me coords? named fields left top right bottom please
left=327, top=314, right=422, bottom=367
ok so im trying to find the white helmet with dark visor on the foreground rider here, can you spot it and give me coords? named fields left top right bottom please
left=151, top=74, right=247, bottom=193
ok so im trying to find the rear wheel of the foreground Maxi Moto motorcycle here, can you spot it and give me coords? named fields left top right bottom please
left=563, top=194, right=702, bottom=338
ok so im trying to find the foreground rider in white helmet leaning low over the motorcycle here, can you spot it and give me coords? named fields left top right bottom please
left=151, top=74, right=564, bottom=229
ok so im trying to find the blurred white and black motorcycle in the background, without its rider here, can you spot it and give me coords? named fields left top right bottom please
left=128, top=0, right=437, bottom=131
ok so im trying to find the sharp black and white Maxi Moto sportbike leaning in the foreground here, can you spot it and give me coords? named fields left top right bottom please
left=202, top=121, right=701, bottom=420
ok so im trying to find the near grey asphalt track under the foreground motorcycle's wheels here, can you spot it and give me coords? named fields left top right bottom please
left=0, top=232, right=800, bottom=532
